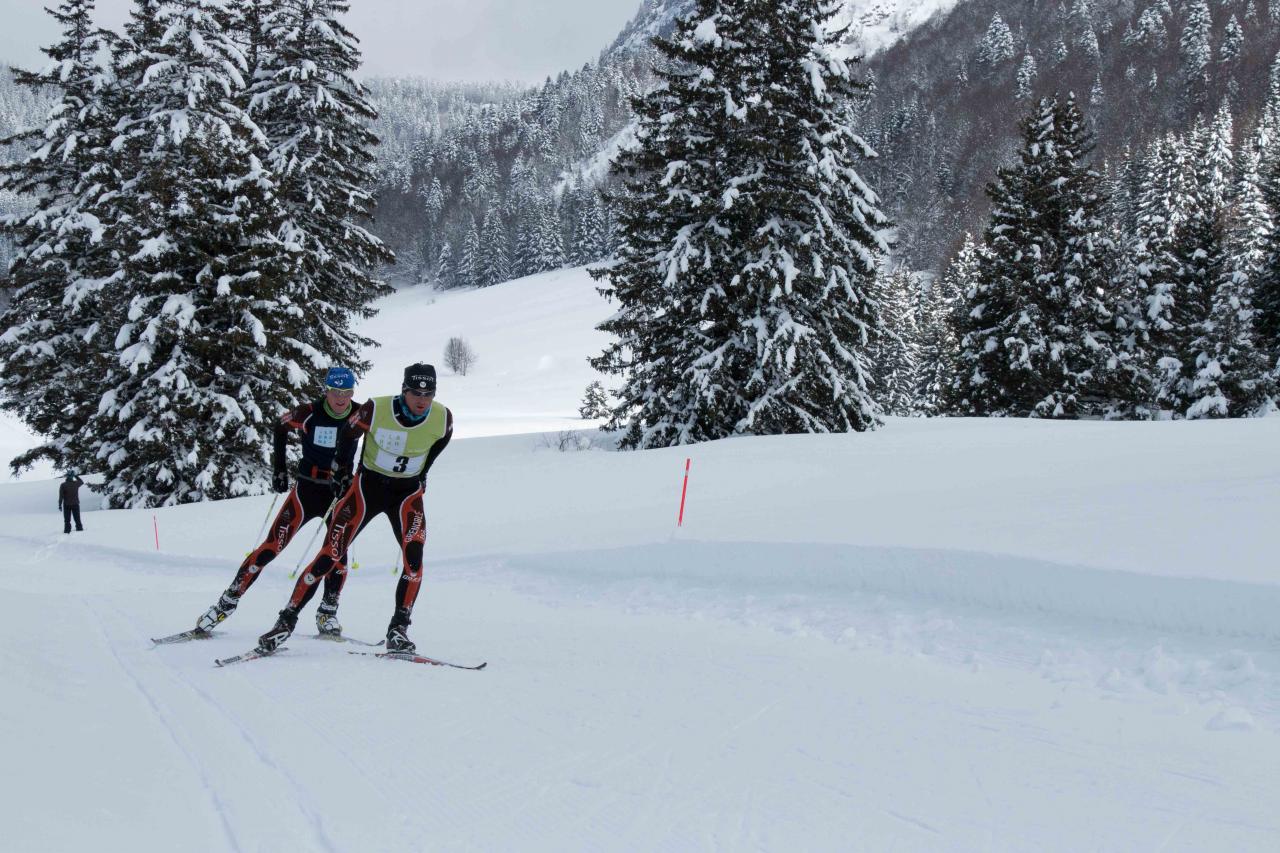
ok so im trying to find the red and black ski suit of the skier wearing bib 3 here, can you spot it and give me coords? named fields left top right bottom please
left=285, top=397, right=453, bottom=625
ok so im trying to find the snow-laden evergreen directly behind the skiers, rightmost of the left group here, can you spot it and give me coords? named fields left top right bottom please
left=250, top=0, right=394, bottom=371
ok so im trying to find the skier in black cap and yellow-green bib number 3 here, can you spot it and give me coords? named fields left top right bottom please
left=257, top=364, right=453, bottom=653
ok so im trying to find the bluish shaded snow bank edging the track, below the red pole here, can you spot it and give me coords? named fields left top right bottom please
left=507, top=542, right=1280, bottom=639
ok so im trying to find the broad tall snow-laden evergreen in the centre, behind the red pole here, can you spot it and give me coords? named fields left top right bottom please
left=594, top=0, right=884, bottom=447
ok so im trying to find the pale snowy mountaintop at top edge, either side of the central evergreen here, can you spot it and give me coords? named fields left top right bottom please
left=609, top=0, right=960, bottom=55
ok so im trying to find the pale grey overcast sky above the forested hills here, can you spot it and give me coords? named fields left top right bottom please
left=0, top=0, right=640, bottom=83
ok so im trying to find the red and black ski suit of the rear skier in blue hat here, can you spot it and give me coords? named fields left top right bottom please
left=227, top=397, right=360, bottom=599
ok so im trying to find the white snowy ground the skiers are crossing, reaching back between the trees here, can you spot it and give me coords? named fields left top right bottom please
left=0, top=270, right=1280, bottom=853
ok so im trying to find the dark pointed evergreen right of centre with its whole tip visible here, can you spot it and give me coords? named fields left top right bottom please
left=957, top=96, right=1128, bottom=418
